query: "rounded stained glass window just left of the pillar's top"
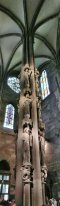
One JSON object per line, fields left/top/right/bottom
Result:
{"left": 7, "top": 77, "right": 20, "bottom": 93}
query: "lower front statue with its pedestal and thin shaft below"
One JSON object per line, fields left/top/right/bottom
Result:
{"left": 22, "top": 114, "right": 32, "bottom": 206}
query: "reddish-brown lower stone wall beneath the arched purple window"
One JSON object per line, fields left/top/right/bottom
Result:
{"left": 0, "top": 131, "right": 16, "bottom": 198}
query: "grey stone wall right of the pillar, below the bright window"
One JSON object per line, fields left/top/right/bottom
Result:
{"left": 42, "top": 65, "right": 60, "bottom": 199}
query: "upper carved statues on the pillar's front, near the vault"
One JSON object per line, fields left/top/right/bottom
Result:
{"left": 19, "top": 64, "right": 32, "bottom": 118}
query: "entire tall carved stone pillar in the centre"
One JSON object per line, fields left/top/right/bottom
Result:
{"left": 16, "top": 35, "right": 44, "bottom": 206}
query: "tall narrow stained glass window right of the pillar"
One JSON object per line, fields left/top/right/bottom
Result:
{"left": 40, "top": 70, "right": 50, "bottom": 99}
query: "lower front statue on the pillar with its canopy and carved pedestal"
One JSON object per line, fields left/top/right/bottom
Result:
{"left": 22, "top": 114, "right": 32, "bottom": 184}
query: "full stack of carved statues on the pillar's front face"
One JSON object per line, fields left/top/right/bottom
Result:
{"left": 19, "top": 64, "right": 33, "bottom": 188}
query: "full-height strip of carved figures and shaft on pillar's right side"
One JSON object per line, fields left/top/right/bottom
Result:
{"left": 35, "top": 66, "right": 47, "bottom": 205}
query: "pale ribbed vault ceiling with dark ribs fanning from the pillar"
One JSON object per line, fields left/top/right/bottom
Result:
{"left": 0, "top": 0, "right": 60, "bottom": 99}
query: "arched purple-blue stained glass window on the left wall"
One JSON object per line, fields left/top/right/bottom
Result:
{"left": 4, "top": 104, "right": 14, "bottom": 129}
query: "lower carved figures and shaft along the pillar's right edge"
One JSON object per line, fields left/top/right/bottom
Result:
{"left": 38, "top": 118, "right": 47, "bottom": 205}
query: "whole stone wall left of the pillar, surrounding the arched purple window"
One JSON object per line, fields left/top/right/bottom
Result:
{"left": 0, "top": 79, "right": 18, "bottom": 197}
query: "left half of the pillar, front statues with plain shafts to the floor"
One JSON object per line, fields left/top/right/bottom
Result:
{"left": 16, "top": 64, "right": 32, "bottom": 206}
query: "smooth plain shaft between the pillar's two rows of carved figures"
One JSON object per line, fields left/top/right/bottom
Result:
{"left": 30, "top": 64, "right": 42, "bottom": 206}
